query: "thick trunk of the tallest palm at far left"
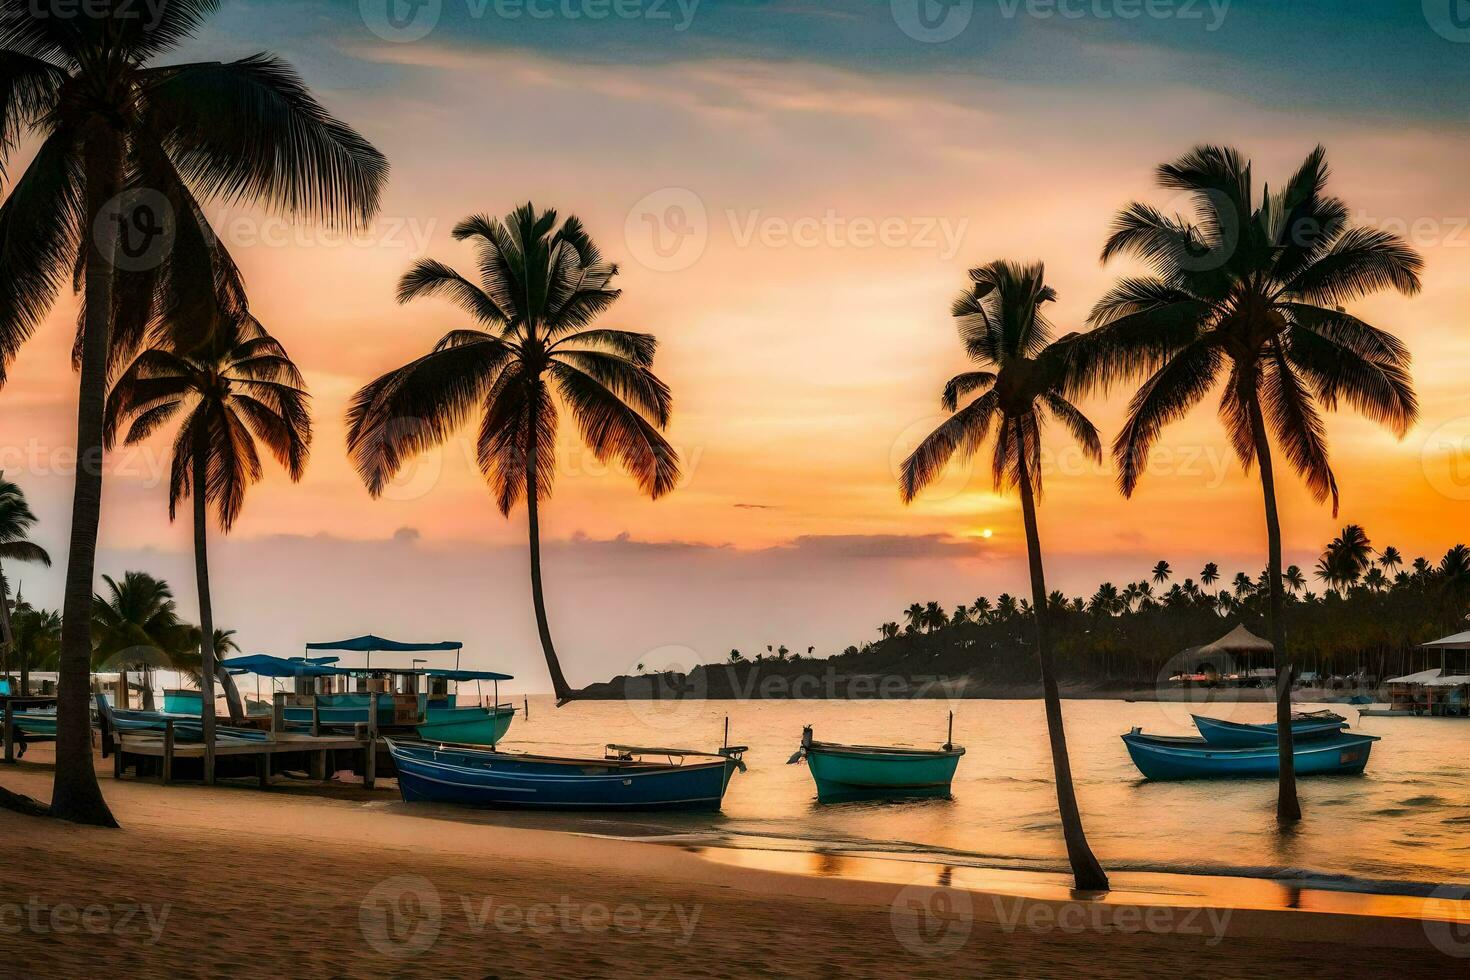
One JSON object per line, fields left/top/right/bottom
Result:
{"left": 51, "top": 123, "right": 122, "bottom": 827}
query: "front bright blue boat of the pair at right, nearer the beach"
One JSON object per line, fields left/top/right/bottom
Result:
{"left": 1123, "top": 729, "right": 1379, "bottom": 780}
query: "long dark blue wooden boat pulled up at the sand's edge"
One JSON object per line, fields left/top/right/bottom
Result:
{"left": 384, "top": 739, "right": 745, "bottom": 810}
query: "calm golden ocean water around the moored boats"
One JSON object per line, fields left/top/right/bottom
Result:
{"left": 473, "top": 698, "right": 1470, "bottom": 890}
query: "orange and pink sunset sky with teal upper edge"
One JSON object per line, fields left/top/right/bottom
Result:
{"left": 0, "top": 0, "right": 1470, "bottom": 691}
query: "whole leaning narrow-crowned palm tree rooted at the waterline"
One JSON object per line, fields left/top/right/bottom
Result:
{"left": 901, "top": 262, "right": 1107, "bottom": 890}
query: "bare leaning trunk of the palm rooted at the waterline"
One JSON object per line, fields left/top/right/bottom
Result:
{"left": 1020, "top": 450, "right": 1108, "bottom": 892}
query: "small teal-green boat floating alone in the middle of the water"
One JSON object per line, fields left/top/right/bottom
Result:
{"left": 786, "top": 716, "right": 964, "bottom": 804}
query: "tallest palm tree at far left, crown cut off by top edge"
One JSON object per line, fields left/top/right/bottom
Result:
{"left": 0, "top": 0, "right": 388, "bottom": 826}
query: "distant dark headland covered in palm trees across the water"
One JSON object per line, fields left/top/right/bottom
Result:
{"left": 842, "top": 525, "right": 1470, "bottom": 686}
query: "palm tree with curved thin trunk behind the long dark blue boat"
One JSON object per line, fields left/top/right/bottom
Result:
{"left": 347, "top": 203, "right": 679, "bottom": 704}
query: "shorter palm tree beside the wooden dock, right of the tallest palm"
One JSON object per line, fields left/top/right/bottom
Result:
{"left": 103, "top": 313, "right": 312, "bottom": 783}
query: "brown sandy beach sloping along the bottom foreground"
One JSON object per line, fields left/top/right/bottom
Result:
{"left": 0, "top": 746, "right": 1467, "bottom": 977}
